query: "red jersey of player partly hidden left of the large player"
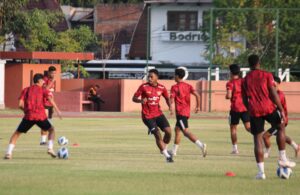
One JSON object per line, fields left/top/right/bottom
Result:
{"left": 226, "top": 78, "right": 247, "bottom": 112}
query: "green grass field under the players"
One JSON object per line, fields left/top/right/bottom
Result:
{"left": 0, "top": 113, "right": 300, "bottom": 195}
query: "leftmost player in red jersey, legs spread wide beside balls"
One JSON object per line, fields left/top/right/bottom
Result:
{"left": 4, "top": 74, "right": 61, "bottom": 159}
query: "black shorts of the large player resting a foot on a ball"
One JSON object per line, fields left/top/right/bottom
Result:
{"left": 250, "top": 110, "right": 281, "bottom": 135}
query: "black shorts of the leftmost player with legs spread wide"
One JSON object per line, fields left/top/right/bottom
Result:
{"left": 17, "top": 118, "right": 52, "bottom": 133}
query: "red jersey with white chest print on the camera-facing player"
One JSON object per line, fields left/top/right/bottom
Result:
{"left": 134, "top": 83, "right": 168, "bottom": 119}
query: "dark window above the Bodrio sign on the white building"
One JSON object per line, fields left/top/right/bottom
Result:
{"left": 168, "top": 11, "right": 198, "bottom": 31}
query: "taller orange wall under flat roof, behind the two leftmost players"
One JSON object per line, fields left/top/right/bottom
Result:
{"left": 5, "top": 63, "right": 61, "bottom": 108}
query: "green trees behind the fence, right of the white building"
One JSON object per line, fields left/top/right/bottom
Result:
{"left": 209, "top": 0, "right": 300, "bottom": 70}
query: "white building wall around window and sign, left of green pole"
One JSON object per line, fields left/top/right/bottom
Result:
{"left": 150, "top": 4, "right": 209, "bottom": 64}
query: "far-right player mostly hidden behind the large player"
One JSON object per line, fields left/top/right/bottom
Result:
{"left": 264, "top": 76, "right": 300, "bottom": 158}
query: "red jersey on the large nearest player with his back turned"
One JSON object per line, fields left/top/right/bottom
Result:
{"left": 243, "top": 70, "right": 276, "bottom": 117}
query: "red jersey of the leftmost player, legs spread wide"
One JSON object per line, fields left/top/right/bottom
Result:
{"left": 19, "top": 85, "right": 49, "bottom": 121}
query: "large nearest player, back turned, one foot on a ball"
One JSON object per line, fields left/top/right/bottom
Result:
{"left": 242, "top": 55, "right": 296, "bottom": 179}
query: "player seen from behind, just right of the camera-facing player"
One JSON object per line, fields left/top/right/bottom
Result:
{"left": 170, "top": 68, "right": 207, "bottom": 157}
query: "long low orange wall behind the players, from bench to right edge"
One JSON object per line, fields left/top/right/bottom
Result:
{"left": 55, "top": 79, "right": 300, "bottom": 113}
